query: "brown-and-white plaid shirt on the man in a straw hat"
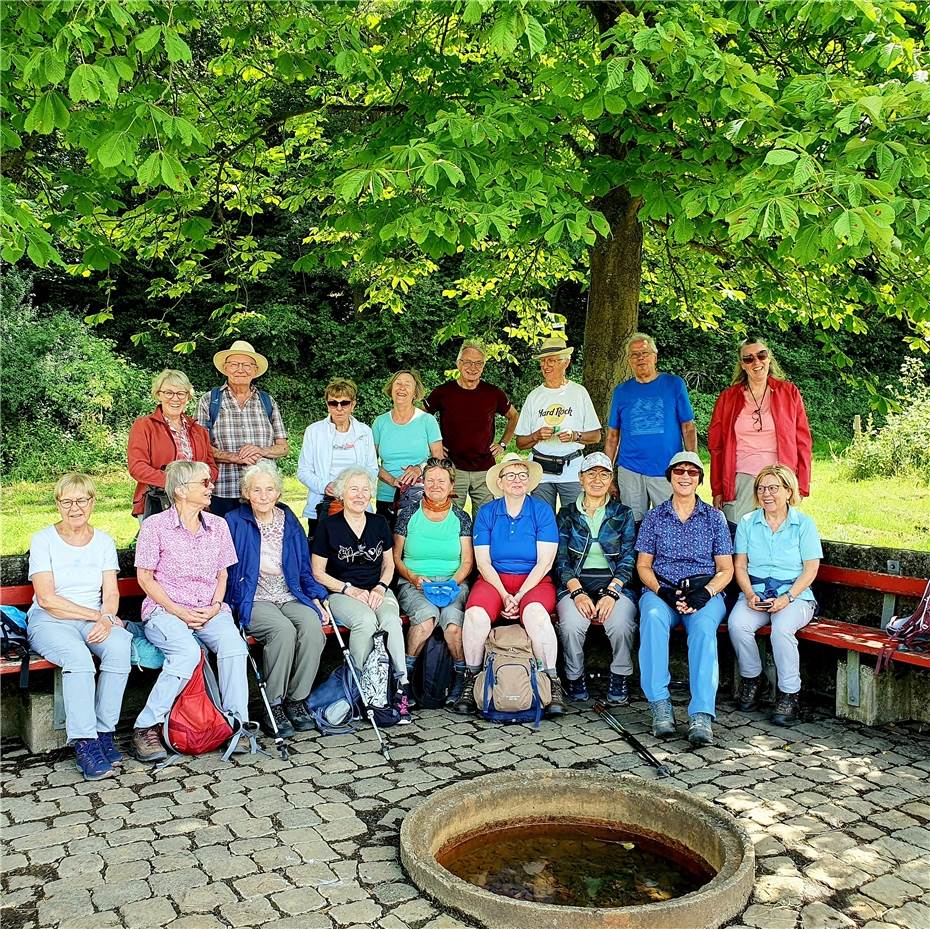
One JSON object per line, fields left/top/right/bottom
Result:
{"left": 197, "top": 384, "right": 287, "bottom": 499}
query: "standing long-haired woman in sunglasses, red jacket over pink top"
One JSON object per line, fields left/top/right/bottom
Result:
{"left": 707, "top": 336, "right": 812, "bottom": 527}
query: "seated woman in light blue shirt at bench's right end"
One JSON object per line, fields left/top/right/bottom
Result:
{"left": 728, "top": 464, "right": 823, "bottom": 726}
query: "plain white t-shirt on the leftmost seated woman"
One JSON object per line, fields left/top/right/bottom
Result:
{"left": 29, "top": 526, "right": 119, "bottom": 610}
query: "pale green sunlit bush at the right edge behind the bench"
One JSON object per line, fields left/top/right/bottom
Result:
{"left": 842, "top": 356, "right": 930, "bottom": 484}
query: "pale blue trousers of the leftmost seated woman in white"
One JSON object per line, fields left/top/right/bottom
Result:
{"left": 29, "top": 606, "right": 132, "bottom": 741}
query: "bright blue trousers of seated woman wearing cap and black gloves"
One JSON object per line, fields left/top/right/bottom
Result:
{"left": 639, "top": 590, "right": 725, "bottom": 716}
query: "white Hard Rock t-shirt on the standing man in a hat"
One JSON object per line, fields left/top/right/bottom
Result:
{"left": 517, "top": 381, "right": 601, "bottom": 484}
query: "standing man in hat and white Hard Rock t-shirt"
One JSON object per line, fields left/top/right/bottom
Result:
{"left": 517, "top": 335, "right": 601, "bottom": 512}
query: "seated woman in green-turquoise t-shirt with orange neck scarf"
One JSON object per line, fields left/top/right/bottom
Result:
{"left": 394, "top": 458, "right": 475, "bottom": 703}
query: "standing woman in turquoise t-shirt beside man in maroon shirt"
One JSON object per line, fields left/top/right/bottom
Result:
{"left": 371, "top": 370, "right": 442, "bottom": 521}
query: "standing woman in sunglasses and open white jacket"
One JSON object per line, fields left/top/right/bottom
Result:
{"left": 297, "top": 377, "right": 378, "bottom": 539}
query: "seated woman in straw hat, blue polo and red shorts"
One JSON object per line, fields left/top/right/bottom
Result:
{"left": 455, "top": 455, "right": 563, "bottom": 716}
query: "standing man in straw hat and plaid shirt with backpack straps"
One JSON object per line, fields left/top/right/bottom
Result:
{"left": 197, "top": 339, "right": 288, "bottom": 516}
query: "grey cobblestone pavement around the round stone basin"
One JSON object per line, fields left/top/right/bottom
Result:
{"left": 2, "top": 703, "right": 930, "bottom": 929}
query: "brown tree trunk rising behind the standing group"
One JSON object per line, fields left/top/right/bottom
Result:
{"left": 583, "top": 180, "right": 643, "bottom": 429}
